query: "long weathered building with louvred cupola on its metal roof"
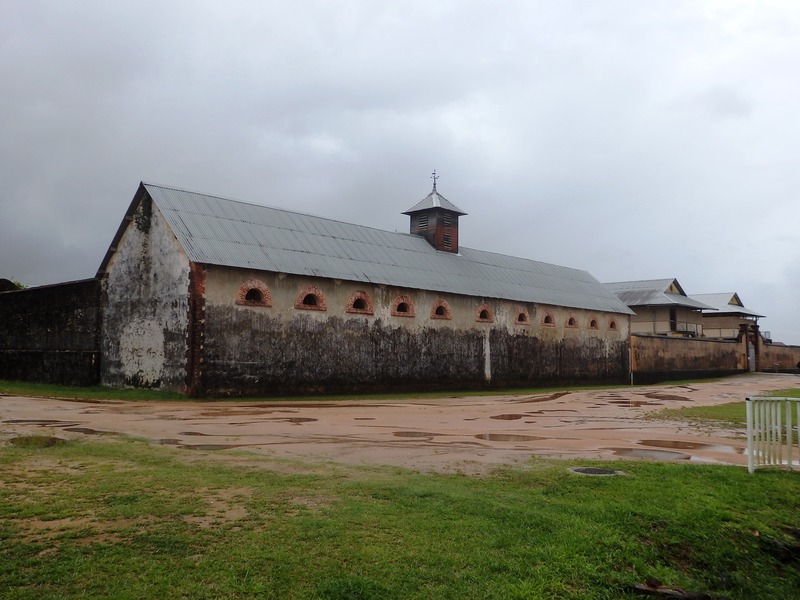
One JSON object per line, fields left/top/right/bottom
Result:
{"left": 98, "top": 178, "right": 632, "bottom": 394}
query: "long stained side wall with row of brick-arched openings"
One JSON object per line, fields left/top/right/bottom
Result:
{"left": 198, "top": 266, "right": 628, "bottom": 394}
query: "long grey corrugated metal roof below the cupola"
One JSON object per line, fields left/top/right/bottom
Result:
{"left": 142, "top": 183, "right": 632, "bottom": 314}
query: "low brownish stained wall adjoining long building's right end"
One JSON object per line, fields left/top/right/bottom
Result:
{"left": 630, "top": 334, "right": 747, "bottom": 383}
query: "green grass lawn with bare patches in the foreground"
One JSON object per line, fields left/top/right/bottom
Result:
{"left": 0, "top": 438, "right": 800, "bottom": 600}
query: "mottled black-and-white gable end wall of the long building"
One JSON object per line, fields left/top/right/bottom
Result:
{"left": 101, "top": 194, "right": 189, "bottom": 391}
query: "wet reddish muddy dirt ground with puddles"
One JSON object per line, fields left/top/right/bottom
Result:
{"left": 0, "top": 374, "right": 800, "bottom": 473}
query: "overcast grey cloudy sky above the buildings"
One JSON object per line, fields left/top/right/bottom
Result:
{"left": 0, "top": 0, "right": 800, "bottom": 344}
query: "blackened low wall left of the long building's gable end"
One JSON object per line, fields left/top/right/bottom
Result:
{"left": 0, "top": 279, "right": 101, "bottom": 385}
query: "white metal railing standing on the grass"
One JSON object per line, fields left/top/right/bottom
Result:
{"left": 747, "top": 397, "right": 800, "bottom": 473}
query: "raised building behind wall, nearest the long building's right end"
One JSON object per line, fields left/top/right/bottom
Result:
{"left": 605, "top": 279, "right": 713, "bottom": 337}
